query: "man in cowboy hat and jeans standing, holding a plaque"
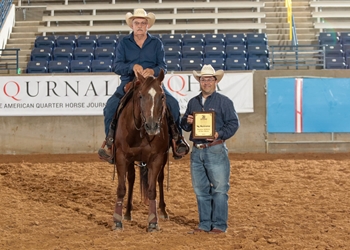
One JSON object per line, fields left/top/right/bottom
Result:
{"left": 181, "top": 65, "right": 239, "bottom": 234}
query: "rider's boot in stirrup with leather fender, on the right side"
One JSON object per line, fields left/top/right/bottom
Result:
{"left": 166, "top": 109, "right": 190, "bottom": 160}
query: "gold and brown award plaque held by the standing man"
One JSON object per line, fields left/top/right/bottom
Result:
{"left": 192, "top": 111, "right": 215, "bottom": 139}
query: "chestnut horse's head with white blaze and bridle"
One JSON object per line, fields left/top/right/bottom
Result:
{"left": 139, "top": 70, "right": 165, "bottom": 135}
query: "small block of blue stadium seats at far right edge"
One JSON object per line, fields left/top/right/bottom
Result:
{"left": 318, "top": 32, "right": 350, "bottom": 69}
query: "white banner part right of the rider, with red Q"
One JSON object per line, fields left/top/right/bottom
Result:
{"left": 164, "top": 72, "right": 254, "bottom": 114}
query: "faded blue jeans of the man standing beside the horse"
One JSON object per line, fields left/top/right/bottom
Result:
{"left": 191, "top": 143, "right": 230, "bottom": 231}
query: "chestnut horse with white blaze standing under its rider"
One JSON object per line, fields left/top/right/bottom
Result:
{"left": 113, "top": 71, "right": 169, "bottom": 232}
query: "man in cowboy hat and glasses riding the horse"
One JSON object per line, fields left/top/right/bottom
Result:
{"left": 98, "top": 9, "right": 189, "bottom": 163}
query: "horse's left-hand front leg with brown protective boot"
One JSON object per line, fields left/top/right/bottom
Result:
{"left": 112, "top": 170, "right": 126, "bottom": 230}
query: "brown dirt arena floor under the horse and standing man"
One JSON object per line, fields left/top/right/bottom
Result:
{"left": 0, "top": 151, "right": 350, "bottom": 250}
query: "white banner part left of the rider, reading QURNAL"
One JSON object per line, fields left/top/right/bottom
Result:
{"left": 0, "top": 75, "right": 119, "bottom": 116}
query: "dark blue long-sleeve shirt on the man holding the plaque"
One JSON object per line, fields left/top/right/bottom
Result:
{"left": 181, "top": 92, "right": 240, "bottom": 143}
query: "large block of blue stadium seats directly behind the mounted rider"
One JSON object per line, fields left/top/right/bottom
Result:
{"left": 27, "top": 33, "right": 269, "bottom": 73}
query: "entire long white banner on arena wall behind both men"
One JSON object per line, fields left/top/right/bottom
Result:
{"left": 0, "top": 73, "right": 254, "bottom": 116}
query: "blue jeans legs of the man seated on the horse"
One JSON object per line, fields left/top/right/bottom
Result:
{"left": 103, "top": 88, "right": 182, "bottom": 137}
